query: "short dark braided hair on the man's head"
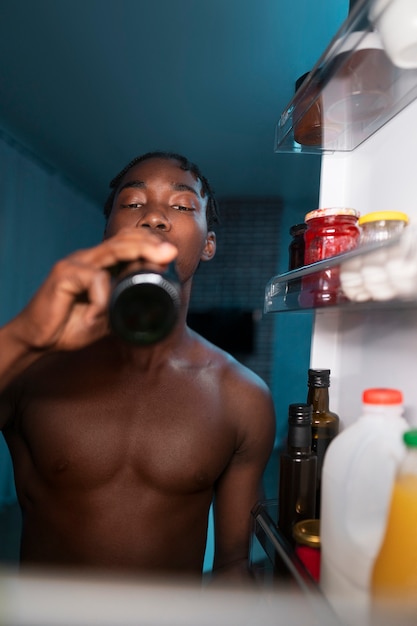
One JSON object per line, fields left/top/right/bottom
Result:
{"left": 104, "top": 152, "right": 219, "bottom": 230}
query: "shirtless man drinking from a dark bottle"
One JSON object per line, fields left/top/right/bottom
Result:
{"left": 0, "top": 153, "right": 275, "bottom": 578}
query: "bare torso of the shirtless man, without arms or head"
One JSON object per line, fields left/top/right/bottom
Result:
{"left": 4, "top": 334, "right": 240, "bottom": 573}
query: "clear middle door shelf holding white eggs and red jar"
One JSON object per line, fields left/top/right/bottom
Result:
{"left": 264, "top": 226, "right": 417, "bottom": 313}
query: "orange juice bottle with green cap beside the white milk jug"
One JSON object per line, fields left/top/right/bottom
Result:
{"left": 372, "top": 430, "right": 417, "bottom": 601}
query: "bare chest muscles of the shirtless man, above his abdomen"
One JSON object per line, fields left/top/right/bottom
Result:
{"left": 13, "top": 366, "right": 235, "bottom": 492}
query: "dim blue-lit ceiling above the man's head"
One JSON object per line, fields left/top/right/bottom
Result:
{"left": 0, "top": 0, "right": 348, "bottom": 210}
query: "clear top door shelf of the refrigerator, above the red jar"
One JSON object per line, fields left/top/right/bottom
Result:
{"left": 275, "top": 0, "right": 417, "bottom": 154}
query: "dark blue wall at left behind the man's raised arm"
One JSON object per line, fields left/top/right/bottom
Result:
{"left": 0, "top": 134, "right": 104, "bottom": 506}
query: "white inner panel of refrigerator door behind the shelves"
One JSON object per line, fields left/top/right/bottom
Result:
{"left": 314, "top": 101, "right": 417, "bottom": 426}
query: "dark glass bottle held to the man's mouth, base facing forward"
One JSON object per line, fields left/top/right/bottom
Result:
{"left": 109, "top": 262, "right": 180, "bottom": 346}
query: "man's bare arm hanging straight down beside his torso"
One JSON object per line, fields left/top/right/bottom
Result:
{"left": 213, "top": 370, "right": 275, "bottom": 582}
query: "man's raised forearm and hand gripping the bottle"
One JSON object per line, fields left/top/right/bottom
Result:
{"left": 0, "top": 229, "right": 176, "bottom": 391}
